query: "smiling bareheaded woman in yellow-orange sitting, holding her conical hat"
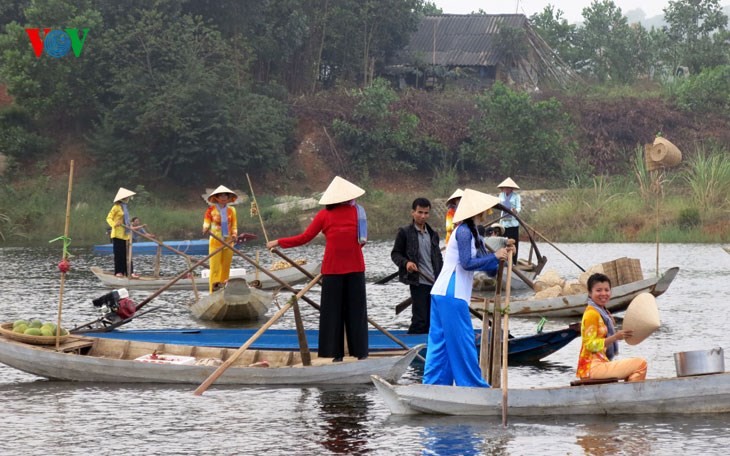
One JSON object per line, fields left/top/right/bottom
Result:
{"left": 577, "top": 273, "right": 647, "bottom": 382}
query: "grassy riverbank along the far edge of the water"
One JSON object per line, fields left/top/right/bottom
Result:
{"left": 0, "top": 167, "right": 730, "bottom": 247}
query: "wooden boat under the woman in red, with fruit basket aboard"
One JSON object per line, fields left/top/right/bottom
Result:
{"left": 0, "top": 335, "right": 420, "bottom": 385}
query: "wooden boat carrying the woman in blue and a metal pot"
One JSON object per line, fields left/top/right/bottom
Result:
{"left": 373, "top": 372, "right": 730, "bottom": 416}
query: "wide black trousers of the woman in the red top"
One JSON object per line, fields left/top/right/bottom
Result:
{"left": 319, "top": 272, "right": 368, "bottom": 358}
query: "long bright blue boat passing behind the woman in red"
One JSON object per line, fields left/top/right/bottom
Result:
{"left": 86, "top": 324, "right": 580, "bottom": 364}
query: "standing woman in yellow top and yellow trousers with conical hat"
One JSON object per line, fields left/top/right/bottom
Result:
{"left": 203, "top": 185, "right": 238, "bottom": 293}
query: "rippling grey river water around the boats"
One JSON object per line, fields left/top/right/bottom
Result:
{"left": 0, "top": 242, "right": 730, "bottom": 455}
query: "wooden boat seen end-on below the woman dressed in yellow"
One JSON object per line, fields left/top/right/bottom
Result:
{"left": 190, "top": 279, "right": 274, "bottom": 321}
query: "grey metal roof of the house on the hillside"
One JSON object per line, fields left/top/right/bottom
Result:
{"left": 405, "top": 14, "right": 527, "bottom": 66}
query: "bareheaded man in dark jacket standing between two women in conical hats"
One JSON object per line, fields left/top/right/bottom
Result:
{"left": 390, "top": 198, "right": 443, "bottom": 334}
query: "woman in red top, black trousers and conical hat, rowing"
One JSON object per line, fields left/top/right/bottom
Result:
{"left": 266, "top": 176, "right": 368, "bottom": 362}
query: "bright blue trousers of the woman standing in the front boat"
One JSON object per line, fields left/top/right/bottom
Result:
{"left": 423, "top": 274, "right": 489, "bottom": 388}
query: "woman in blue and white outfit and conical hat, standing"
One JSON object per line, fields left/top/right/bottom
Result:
{"left": 423, "top": 189, "right": 514, "bottom": 388}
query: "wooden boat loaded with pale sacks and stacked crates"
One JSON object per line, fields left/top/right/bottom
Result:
{"left": 471, "top": 267, "right": 679, "bottom": 318}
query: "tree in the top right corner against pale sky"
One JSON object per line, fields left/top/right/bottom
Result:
{"left": 664, "top": 0, "right": 730, "bottom": 74}
